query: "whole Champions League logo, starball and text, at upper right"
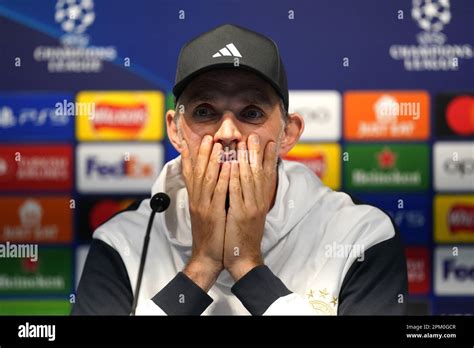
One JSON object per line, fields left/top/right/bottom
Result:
{"left": 389, "top": 0, "right": 473, "bottom": 71}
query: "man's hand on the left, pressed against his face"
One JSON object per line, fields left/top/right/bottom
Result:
{"left": 181, "top": 135, "right": 230, "bottom": 291}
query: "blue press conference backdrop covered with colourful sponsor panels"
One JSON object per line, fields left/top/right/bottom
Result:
{"left": 0, "top": 0, "right": 474, "bottom": 315}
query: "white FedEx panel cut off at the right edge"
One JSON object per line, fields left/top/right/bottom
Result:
{"left": 435, "top": 246, "right": 474, "bottom": 296}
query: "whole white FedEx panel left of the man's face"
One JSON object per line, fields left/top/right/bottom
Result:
{"left": 76, "top": 143, "right": 164, "bottom": 193}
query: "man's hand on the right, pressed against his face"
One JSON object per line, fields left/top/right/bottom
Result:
{"left": 224, "top": 134, "right": 277, "bottom": 281}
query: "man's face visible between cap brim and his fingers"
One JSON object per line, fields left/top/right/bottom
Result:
{"left": 174, "top": 69, "right": 284, "bottom": 166}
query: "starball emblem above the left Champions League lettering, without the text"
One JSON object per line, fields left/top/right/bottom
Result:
{"left": 54, "top": 0, "right": 95, "bottom": 46}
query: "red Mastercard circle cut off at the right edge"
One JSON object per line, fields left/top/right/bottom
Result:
{"left": 446, "top": 96, "right": 474, "bottom": 135}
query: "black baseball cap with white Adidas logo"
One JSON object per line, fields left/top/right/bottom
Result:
{"left": 173, "top": 24, "right": 288, "bottom": 110}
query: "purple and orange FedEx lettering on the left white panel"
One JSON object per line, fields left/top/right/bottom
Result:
{"left": 86, "top": 156, "right": 153, "bottom": 178}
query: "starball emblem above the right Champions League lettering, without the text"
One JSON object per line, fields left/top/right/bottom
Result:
{"left": 411, "top": 0, "right": 451, "bottom": 45}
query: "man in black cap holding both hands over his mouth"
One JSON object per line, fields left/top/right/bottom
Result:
{"left": 73, "top": 25, "right": 407, "bottom": 315}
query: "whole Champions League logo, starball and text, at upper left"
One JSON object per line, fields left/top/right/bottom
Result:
{"left": 33, "top": 0, "right": 117, "bottom": 73}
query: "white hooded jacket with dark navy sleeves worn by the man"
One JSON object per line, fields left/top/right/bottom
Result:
{"left": 73, "top": 157, "right": 407, "bottom": 315}
